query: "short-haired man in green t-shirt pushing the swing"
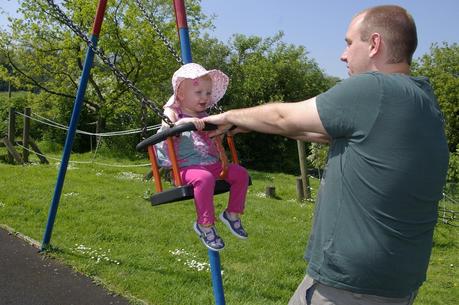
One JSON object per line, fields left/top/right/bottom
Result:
{"left": 205, "top": 6, "right": 448, "bottom": 305}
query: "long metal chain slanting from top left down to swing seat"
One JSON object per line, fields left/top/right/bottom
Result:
{"left": 46, "top": 0, "right": 174, "bottom": 127}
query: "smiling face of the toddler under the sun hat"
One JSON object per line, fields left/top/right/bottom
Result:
{"left": 177, "top": 76, "right": 212, "bottom": 116}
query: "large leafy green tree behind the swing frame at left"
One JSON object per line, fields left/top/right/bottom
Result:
{"left": 0, "top": 0, "right": 210, "bottom": 150}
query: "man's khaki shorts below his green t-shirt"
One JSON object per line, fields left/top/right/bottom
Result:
{"left": 288, "top": 275, "right": 417, "bottom": 305}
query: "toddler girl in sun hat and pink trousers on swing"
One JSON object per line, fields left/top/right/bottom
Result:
{"left": 157, "top": 63, "right": 249, "bottom": 251}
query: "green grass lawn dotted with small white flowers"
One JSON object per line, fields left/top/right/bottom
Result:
{"left": 0, "top": 149, "right": 459, "bottom": 305}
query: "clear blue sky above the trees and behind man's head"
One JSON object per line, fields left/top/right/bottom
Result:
{"left": 0, "top": 0, "right": 459, "bottom": 78}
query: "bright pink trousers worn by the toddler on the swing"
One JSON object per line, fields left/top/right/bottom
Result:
{"left": 180, "top": 163, "right": 249, "bottom": 224}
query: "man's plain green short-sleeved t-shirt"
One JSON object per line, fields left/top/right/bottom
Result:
{"left": 305, "top": 72, "right": 448, "bottom": 297}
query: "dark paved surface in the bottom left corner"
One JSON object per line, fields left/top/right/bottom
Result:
{"left": 0, "top": 227, "right": 133, "bottom": 305}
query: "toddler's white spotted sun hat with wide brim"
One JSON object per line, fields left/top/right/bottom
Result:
{"left": 164, "top": 63, "right": 229, "bottom": 107}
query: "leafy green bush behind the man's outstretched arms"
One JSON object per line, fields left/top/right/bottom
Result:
{"left": 205, "top": 32, "right": 330, "bottom": 173}
